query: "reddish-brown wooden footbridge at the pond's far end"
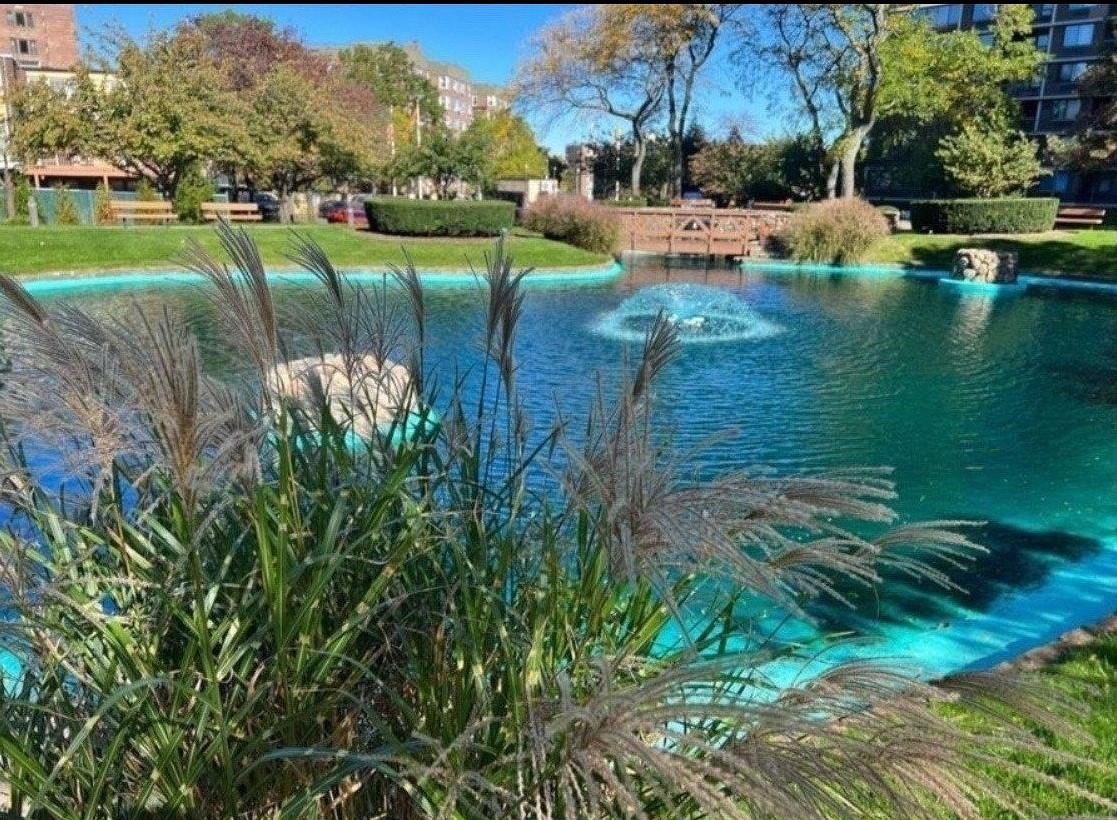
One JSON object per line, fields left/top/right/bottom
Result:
{"left": 617, "top": 208, "right": 791, "bottom": 256}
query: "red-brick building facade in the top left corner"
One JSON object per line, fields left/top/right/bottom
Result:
{"left": 0, "top": 3, "right": 78, "bottom": 69}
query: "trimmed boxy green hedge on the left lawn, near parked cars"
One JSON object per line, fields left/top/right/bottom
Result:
{"left": 364, "top": 197, "right": 516, "bottom": 237}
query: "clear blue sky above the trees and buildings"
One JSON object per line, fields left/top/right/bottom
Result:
{"left": 77, "top": 3, "right": 782, "bottom": 151}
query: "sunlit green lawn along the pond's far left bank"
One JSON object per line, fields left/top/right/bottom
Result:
{"left": 0, "top": 225, "right": 609, "bottom": 276}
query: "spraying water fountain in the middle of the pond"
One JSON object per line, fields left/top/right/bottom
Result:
{"left": 593, "top": 283, "right": 783, "bottom": 344}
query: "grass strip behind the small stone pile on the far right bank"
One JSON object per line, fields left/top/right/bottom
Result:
{"left": 866, "top": 229, "right": 1117, "bottom": 279}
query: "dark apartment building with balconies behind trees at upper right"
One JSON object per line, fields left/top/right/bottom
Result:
{"left": 915, "top": 3, "right": 1117, "bottom": 203}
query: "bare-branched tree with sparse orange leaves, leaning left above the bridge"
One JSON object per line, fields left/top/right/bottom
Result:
{"left": 513, "top": 6, "right": 667, "bottom": 194}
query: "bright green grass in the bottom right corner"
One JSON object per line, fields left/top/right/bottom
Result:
{"left": 957, "top": 635, "right": 1117, "bottom": 819}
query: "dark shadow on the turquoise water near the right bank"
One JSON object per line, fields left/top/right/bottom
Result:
{"left": 811, "top": 522, "right": 1104, "bottom": 631}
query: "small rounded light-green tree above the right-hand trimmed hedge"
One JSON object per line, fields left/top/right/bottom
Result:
{"left": 936, "top": 117, "right": 1048, "bottom": 198}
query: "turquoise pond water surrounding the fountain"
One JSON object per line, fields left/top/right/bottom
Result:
{"left": 4, "top": 258, "right": 1117, "bottom": 675}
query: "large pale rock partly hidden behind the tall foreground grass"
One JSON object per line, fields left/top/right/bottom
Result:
{"left": 266, "top": 353, "right": 412, "bottom": 438}
